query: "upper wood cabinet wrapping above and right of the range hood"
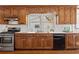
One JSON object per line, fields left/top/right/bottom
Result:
{"left": 4, "top": 7, "right": 26, "bottom": 24}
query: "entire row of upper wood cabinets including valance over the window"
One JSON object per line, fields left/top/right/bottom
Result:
{"left": 0, "top": 6, "right": 76, "bottom": 24}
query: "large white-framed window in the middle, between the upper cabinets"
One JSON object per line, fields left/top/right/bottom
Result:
{"left": 28, "top": 13, "right": 56, "bottom": 32}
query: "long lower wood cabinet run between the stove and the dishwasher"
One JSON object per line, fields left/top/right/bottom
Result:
{"left": 15, "top": 34, "right": 53, "bottom": 49}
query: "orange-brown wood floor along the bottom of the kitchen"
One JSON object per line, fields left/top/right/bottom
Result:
{"left": 0, "top": 50, "right": 79, "bottom": 54}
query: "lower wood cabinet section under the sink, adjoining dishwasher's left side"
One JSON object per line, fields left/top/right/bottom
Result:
{"left": 33, "top": 34, "right": 53, "bottom": 49}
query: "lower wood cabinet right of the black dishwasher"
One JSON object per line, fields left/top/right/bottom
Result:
{"left": 66, "top": 33, "right": 79, "bottom": 49}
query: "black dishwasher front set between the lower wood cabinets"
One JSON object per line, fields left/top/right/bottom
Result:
{"left": 53, "top": 33, "right": 65, "bottom": 50}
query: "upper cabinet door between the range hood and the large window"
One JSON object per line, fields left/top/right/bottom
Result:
{"left": 18, "top": 8, "right": 26, "bottom": 24}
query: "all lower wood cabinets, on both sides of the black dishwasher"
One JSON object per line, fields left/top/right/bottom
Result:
{"left": 15, "top": 33, "right": 79, "bottom": 49}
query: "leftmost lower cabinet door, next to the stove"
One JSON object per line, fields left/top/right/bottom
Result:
{"left": 15, "top": 37, "right": 25, "bottom": 49}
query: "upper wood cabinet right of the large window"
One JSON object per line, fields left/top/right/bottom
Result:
{"left": 58, "top": 6, "right": 76, "bottom": 24}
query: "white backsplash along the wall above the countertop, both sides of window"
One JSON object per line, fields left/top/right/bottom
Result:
{"left": 0, "top": 24, "right": 76, "bottom": 32}
